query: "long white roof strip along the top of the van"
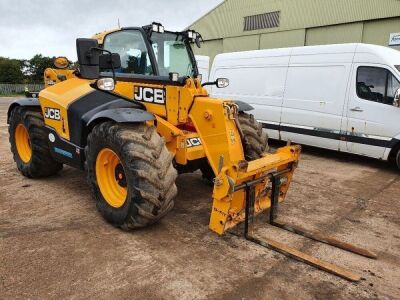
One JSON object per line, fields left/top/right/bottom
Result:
{"left": 215, "top": 43, "right": 400, "bottom": 65}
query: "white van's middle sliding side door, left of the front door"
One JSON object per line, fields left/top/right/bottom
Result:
{"left": 280, "top": 63, "right": 351, "bottom": 150}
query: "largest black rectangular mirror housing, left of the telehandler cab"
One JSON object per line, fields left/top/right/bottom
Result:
{"left": 76, "top": 38, "right": 100, "bottom": 79}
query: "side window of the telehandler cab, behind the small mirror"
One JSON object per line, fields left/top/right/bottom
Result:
{"left": 101, "top": 30, "right": 153, "bottom": 75}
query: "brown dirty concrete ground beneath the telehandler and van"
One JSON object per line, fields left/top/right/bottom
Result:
{"left": 0, "top": 98, "right": 400, "bottom": 299}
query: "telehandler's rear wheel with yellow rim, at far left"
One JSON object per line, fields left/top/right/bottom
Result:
{"left": 8, "top": 106, "right": 63, "bottom": 178}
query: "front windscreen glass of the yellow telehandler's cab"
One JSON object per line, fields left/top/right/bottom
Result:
{"left": 151, "top": 32, "right": 194, "bottom": 77}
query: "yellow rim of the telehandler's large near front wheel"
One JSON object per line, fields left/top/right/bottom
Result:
{"left": 96, "top": 148, "right": 128, "bottom": 208}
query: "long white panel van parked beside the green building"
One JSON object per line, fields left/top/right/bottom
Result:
{"left": 209, "top": 44, "right": 400, "bottom": 167}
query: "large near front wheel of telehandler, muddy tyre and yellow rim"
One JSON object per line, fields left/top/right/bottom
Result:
{"left": 85, "top": 122, "right": 177, "bottom": 230}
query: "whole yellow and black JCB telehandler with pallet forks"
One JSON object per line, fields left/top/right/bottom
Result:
{"left": 8, "top": 23, "right": 374, "bottom": 280}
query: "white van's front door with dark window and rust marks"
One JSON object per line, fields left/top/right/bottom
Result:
{"left": 346, "top": 64, "right": 400, "bottom": 158}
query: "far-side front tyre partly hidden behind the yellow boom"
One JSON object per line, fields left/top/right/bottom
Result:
{"left": 200, "top": 112, "right": 269, "bottom": 182}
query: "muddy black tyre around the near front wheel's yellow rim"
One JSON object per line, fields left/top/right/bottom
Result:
{"left": 85, "top": 122, "right": 177, "bottom": 230}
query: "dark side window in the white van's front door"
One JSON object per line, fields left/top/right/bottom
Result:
{"left": 357, "top": 67, "right": 400, "bottom": 105}
